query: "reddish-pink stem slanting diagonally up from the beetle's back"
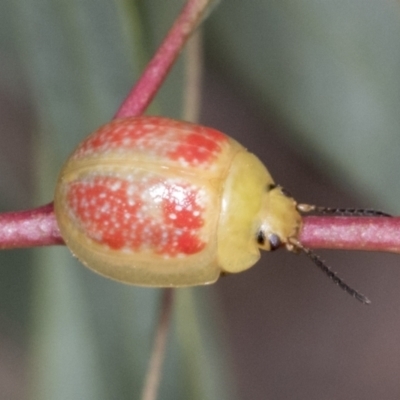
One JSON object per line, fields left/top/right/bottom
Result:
{"left": 114, "top": 0, "right": 210, "bottom": 118}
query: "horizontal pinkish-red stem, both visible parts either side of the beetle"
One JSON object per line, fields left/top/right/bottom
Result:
{"left": 0, "top": 203, "right": 400, "bottom": 253}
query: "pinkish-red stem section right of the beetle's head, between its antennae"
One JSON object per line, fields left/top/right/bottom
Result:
{"left": 299, "top": 216, "right": 400, "bottom": 253}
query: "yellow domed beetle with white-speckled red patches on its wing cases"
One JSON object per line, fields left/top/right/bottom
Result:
{"left": 54, "top": 116, "right": 384, "bottom": 302}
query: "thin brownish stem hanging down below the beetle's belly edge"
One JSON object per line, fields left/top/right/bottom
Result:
{"left": 141, "top": 289, "right": 174, "bottom": 400}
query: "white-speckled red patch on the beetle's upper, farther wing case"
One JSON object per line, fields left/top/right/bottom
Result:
{"left": 74, "top": 117, "right": 228, "bottom": 166}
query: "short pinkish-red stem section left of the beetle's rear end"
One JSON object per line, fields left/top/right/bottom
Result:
{"left": 0, "top": 203, "right": 64, "bottom": 249}
